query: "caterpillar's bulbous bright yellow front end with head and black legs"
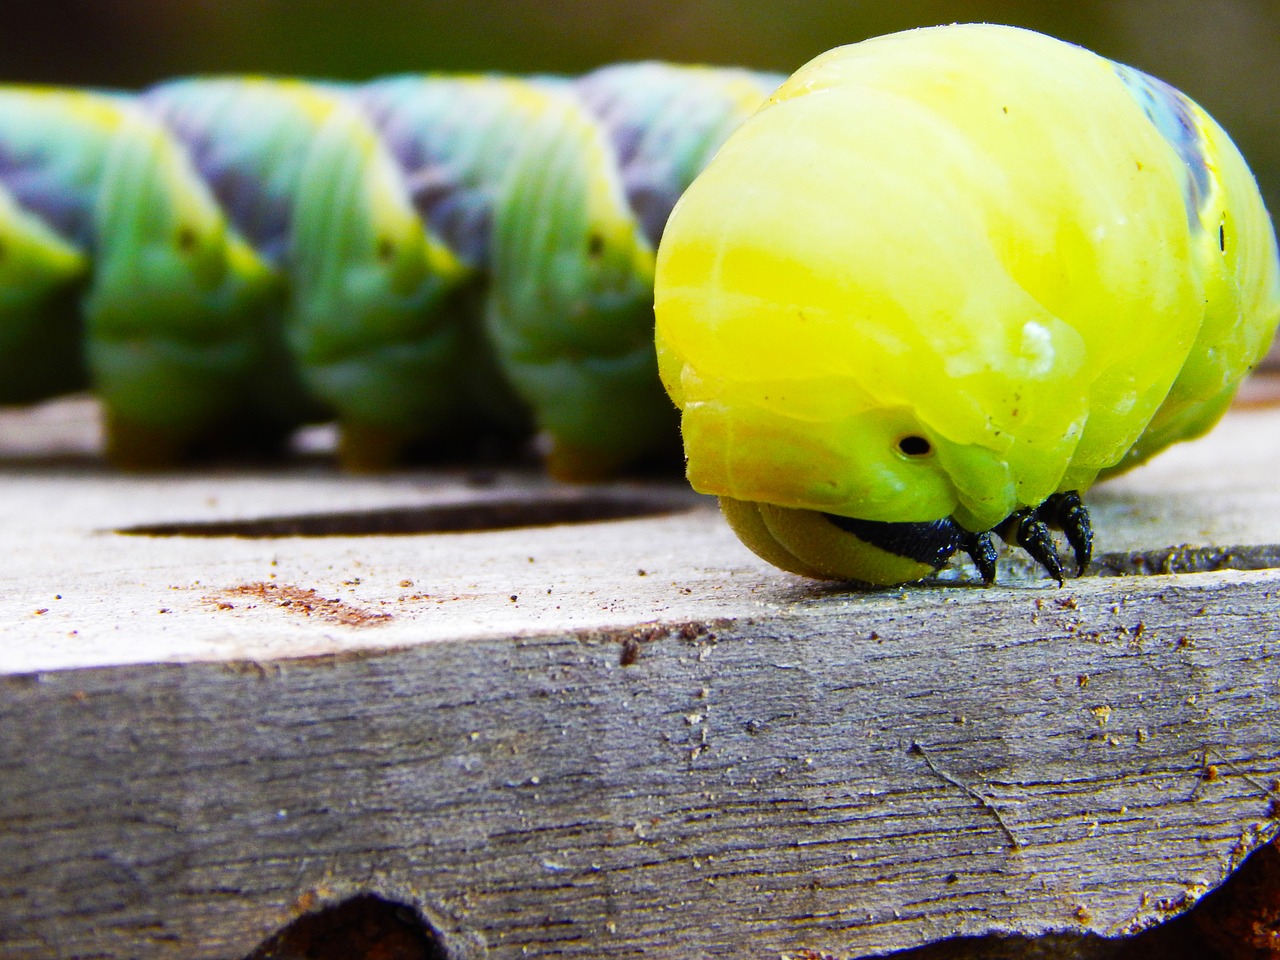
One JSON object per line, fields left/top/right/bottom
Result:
{"left": 655, "top": 24, "right": 1280, "bottom": 584}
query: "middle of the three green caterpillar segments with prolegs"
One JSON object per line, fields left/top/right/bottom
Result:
{"left": 146, "top": 79, "right": 466, "bottom": 468}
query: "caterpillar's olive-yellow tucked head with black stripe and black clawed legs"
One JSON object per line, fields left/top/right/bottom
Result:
{"left": 719, "top": 490, "right": 1093, "bottom": 586}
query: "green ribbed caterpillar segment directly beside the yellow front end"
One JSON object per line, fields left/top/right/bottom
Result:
{"left": 485, "top": 82, "right": 660, "bottom": 479}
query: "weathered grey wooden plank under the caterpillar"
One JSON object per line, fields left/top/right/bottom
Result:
{"left": 0, "top": 394, "right": 1280, "bottom": 960}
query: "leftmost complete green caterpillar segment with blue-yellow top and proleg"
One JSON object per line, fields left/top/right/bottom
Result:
{"left": 0, "top": 90, "right": 284, "bottom": 466}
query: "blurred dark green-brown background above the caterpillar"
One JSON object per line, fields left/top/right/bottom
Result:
{"left": 0, "top": 0, "right": 1280, "bottom": 210}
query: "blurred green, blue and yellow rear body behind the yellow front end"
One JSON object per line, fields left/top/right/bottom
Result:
{"left": 0, "top": 63, "right": 783, "bottom": 480}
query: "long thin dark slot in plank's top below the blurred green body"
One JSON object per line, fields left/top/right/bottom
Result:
{"left": 115, "top": 490, "right": 696, "bottom": 539}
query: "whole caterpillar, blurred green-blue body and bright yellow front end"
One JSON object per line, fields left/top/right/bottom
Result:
{"left": 0, "top": 24, "right": 1280, "bottom": 584}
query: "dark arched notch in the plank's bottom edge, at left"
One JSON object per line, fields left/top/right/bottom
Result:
{"left": 244, "top": 893, "right": 449, "bottom": 960}
